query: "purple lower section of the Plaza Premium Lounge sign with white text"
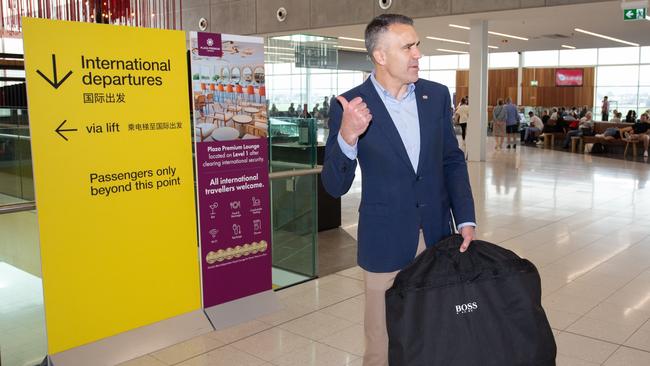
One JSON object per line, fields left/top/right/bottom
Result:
{"left": 196, "top": 139, "right": 272, "bottom": 308}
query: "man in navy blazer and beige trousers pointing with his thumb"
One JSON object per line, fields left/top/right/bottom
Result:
{"left": 322, "top": 14, "right": 476, "bottom": 366}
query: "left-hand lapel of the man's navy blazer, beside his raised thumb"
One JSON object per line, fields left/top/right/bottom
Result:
{"left": 360, "top": 77, "right": 415, "bottom": 174}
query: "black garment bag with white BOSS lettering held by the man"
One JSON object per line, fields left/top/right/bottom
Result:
{"left": 386, "top": 235, "right": 557, "bottom": 366}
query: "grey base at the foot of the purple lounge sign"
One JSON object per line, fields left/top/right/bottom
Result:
{"left": 205, "top": 290, "right": 282, "bottom": 330}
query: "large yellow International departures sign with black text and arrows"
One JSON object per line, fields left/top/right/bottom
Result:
{"left": 23, "top": 18, "right": 201, "bottom": 354}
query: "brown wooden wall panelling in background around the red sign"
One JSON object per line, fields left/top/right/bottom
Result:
{"left": 456, "top": 67, "right": 596, "bottom": 108}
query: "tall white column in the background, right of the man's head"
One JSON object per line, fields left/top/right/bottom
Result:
{"left": 466, "top": 20, "right": 488, "bottom": 161}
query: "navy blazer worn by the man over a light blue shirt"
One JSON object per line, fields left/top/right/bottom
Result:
{"left": 321, "top": 78, "right": 475, "bottom": 272}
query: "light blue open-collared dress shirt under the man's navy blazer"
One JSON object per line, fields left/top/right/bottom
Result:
{"left": 337, "top": 72, "right": 476, "bottom": 230}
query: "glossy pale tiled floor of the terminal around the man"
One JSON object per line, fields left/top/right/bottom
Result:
{"left": 116, "top": 139, "right": 650, "bottom": 366}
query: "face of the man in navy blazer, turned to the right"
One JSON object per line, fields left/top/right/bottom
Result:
{"left": 375, "top": 24, "right": 422, "bottom": 84}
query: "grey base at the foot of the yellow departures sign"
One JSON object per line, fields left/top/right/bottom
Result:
{"left": 49, "top": 310, "right": 213, "bottom": 366}
